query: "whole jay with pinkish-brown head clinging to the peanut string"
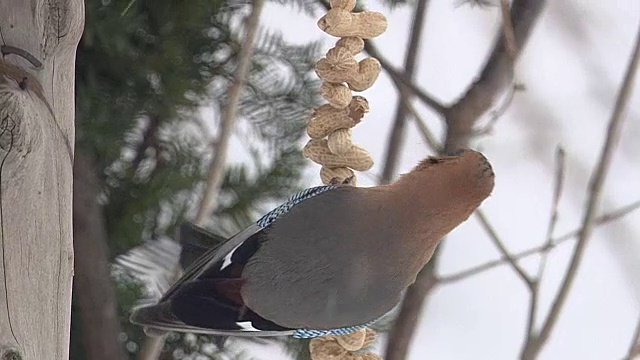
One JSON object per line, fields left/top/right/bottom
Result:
{"left": 131, "top": 150, "right": 494, "bottom": 338}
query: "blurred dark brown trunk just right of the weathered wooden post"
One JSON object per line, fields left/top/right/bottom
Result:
{"left": 73, "top": 152, "right": 127, "bottom": 360}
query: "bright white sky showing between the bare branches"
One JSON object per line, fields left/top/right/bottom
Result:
{"left": 232, "top": 0, "right": 640, "bottom": 360}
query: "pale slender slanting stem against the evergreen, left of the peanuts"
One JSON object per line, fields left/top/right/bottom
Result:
{"left": 138, "top": 0, "right": 264, "bottom": 360}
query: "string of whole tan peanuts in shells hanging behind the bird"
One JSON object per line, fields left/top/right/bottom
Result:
{"left": 303, "top": 0, "right": 387, "bottom": 360}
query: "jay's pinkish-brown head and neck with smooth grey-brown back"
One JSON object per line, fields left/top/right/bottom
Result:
{"left": 242, "top": 151, "right": 494, "bottom": 329}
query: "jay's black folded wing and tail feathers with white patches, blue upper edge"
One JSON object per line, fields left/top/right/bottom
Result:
{"left": 131, "top": 185, "right": 336, "bottom": 336}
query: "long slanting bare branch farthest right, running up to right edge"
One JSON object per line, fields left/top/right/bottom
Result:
{"left": 522, "top": 20, "right": 640, "bottom": 360}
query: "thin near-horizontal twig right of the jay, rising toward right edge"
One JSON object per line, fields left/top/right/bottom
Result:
{"left": 438, "top": 200, "right": 640, "bottom": 284}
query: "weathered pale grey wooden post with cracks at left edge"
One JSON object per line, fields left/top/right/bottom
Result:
{"left": 0, "top": 0, "right": 84, "bottom": 360}
